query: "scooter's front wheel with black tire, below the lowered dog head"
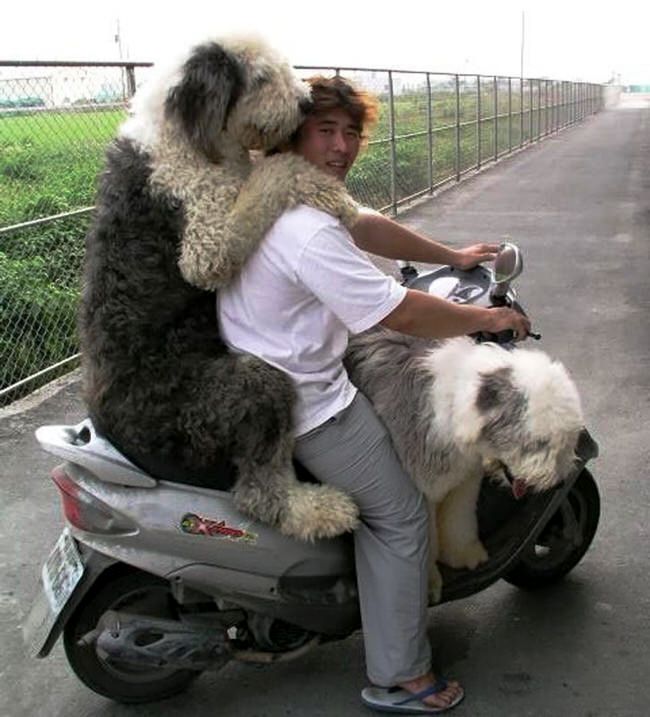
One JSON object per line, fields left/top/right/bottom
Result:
{"left": 504, "top": 470, "right": 600, "bottom": 590}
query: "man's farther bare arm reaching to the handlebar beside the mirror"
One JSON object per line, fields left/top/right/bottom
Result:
{"left": 351, "top": 214, "right": 498, "bottom": 269}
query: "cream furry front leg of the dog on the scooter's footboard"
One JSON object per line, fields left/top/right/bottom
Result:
{"left": 437, "top": 472, "right": 488, "bottom": 570}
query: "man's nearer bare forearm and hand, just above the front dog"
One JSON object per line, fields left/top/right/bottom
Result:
{"left": 379, "top": 289, "right": 530, "bottom": 340}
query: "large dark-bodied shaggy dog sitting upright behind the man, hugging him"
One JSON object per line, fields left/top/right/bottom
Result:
{"left": 80, "top": 33, "right": 357, "bottom": 539}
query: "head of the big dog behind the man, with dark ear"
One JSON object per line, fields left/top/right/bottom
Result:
{"left": 165, "top": 40, "right": 309, "bottom": 160}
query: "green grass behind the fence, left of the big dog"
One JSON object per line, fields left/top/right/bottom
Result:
{"left": 0, "top": 110, "right": 125, "bottom": 389}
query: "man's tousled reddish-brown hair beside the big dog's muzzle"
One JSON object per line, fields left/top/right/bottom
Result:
{"left": 305, "top": 75, "right": 378, "bottom": 133}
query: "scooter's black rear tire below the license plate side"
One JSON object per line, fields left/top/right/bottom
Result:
{"left": 63, "top": 569, "right": 201, "bottom": 704}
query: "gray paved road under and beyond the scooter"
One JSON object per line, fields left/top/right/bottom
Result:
{"left": 0, "top": 104, "right": 650, "bottom": 717}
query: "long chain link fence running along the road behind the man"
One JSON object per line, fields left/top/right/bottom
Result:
{"left": 0, "top": 62, "right": 603, "bottom": 405}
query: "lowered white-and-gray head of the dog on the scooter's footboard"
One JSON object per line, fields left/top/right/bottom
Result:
{"left": 475, "top": 350, "right": 584, "bottom": 497}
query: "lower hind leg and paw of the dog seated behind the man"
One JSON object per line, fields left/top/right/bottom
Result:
{"left": 234, "top": 440, "right": 359, "bottom": 540}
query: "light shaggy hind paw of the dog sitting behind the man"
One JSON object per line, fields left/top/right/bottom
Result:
{"left": 279, "top": 484, "right": 359, "bottom": 540}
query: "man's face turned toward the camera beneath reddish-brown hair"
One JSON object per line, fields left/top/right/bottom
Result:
{"left": 294, "top": 109, "right": 361, "bottom": 180}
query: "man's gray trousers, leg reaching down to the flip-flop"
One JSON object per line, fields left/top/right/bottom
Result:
{"left": 295, "top": 392, "right": 431, "bottom": 687}
